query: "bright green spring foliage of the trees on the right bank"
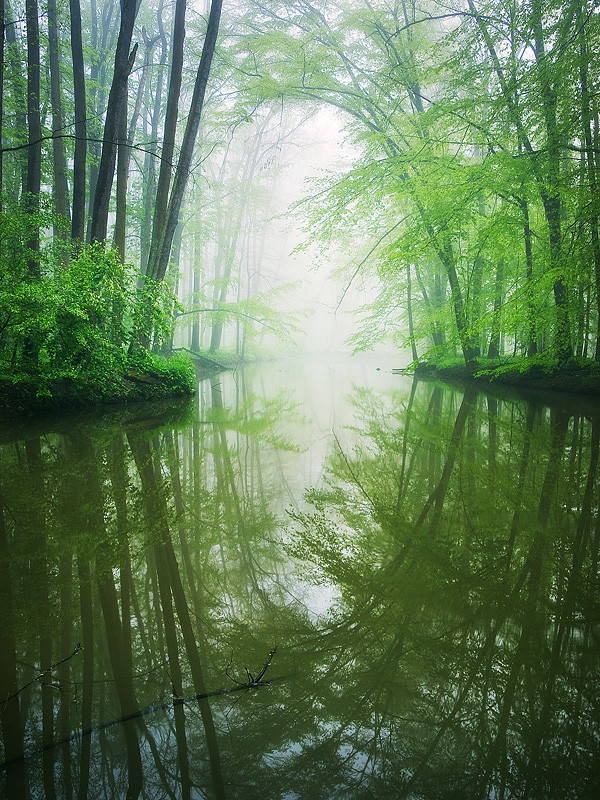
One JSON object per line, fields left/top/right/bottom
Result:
{"left": 237, "top": 0, "right": 600, "bottom": 362}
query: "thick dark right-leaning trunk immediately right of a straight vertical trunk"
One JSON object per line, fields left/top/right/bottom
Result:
{"left": 91, "top": 0, "right": 137, "bottom": 242}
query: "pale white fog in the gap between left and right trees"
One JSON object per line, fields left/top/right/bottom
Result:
{"left": 175, "top": 108, "right": 410, "bottom": 363}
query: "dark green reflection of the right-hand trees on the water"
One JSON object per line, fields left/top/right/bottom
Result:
{"left": 284, "top": 382, "right": 598, "bottom": 798}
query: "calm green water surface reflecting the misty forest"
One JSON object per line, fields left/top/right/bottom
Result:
{"left": 0, "top": 360, "right": 600, "bottom": 800}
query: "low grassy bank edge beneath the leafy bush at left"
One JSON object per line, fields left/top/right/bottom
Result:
{"left": 0, "top": 356, "right": 214, "bottom": 419}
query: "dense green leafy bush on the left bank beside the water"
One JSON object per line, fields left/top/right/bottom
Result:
{"left": 0, "top": 204, "right": 195, "bottom": 410}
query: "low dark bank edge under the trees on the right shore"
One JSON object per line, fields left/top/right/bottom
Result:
{"left": 414, "top": 359, "right": 600, "bottom": 397}
